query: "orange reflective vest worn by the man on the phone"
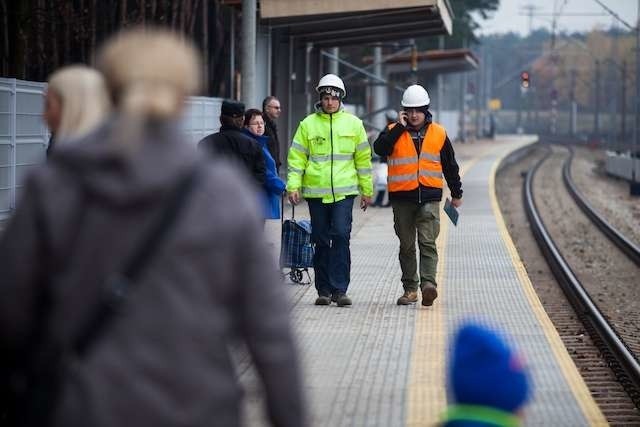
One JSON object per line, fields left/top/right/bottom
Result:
{"left": 387, "top": 123, "right": 447, "bottom": 191}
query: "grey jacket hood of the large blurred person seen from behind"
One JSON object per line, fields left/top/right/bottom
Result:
{"left": 49, "top": 116, "right": 197, "bottom": 206}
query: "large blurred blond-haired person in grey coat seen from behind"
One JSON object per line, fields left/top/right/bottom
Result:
{"left": 0, "top": 29, "right": 305, "bottom": 427}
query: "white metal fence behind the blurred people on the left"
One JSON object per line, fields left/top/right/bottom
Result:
{"left": 0, "top": 78, "right": 222, "bottom": 221}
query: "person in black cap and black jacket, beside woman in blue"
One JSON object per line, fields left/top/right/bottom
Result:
{"left": 198, "top": 99, "right": 266, "bottom": 189}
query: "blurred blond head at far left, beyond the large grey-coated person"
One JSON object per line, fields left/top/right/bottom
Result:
{"left": 44, "top": 65, "right": 111, "bottom": 155}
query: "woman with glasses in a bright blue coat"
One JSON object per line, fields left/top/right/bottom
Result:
{"left": 244, "top": 109, "right": 286, "bottom": 219}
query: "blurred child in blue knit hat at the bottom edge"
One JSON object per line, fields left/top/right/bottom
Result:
{"left": 442, "top": 322, "right": 531, "bottom": 427}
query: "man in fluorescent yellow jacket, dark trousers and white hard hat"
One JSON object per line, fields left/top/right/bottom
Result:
{"left": 287, "top": 74, "right": 373, "bottom": 307}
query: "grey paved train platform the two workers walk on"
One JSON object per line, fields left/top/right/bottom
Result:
{"left": 240, "top": 136, "right": 607, "bottom": 427}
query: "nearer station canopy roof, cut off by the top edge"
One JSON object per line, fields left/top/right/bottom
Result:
{"left": 260, "top": 0, "right": 452, "bottom": 47}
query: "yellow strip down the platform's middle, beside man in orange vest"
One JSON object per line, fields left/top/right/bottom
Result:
{"left": 406, "top": 158, "right": 480, "bottom": 427}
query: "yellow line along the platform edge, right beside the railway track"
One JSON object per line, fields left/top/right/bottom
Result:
{"left": 489, "top": 146, "right": 608, "bottom": 426}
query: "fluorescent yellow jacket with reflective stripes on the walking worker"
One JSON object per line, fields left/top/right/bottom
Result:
{"left": 287, "top": 110, "right": 373, "bottom": 203}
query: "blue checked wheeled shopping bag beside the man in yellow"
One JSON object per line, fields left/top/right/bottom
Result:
{"left": 280, "top": 199, "right": 314, "bottom": 285}
